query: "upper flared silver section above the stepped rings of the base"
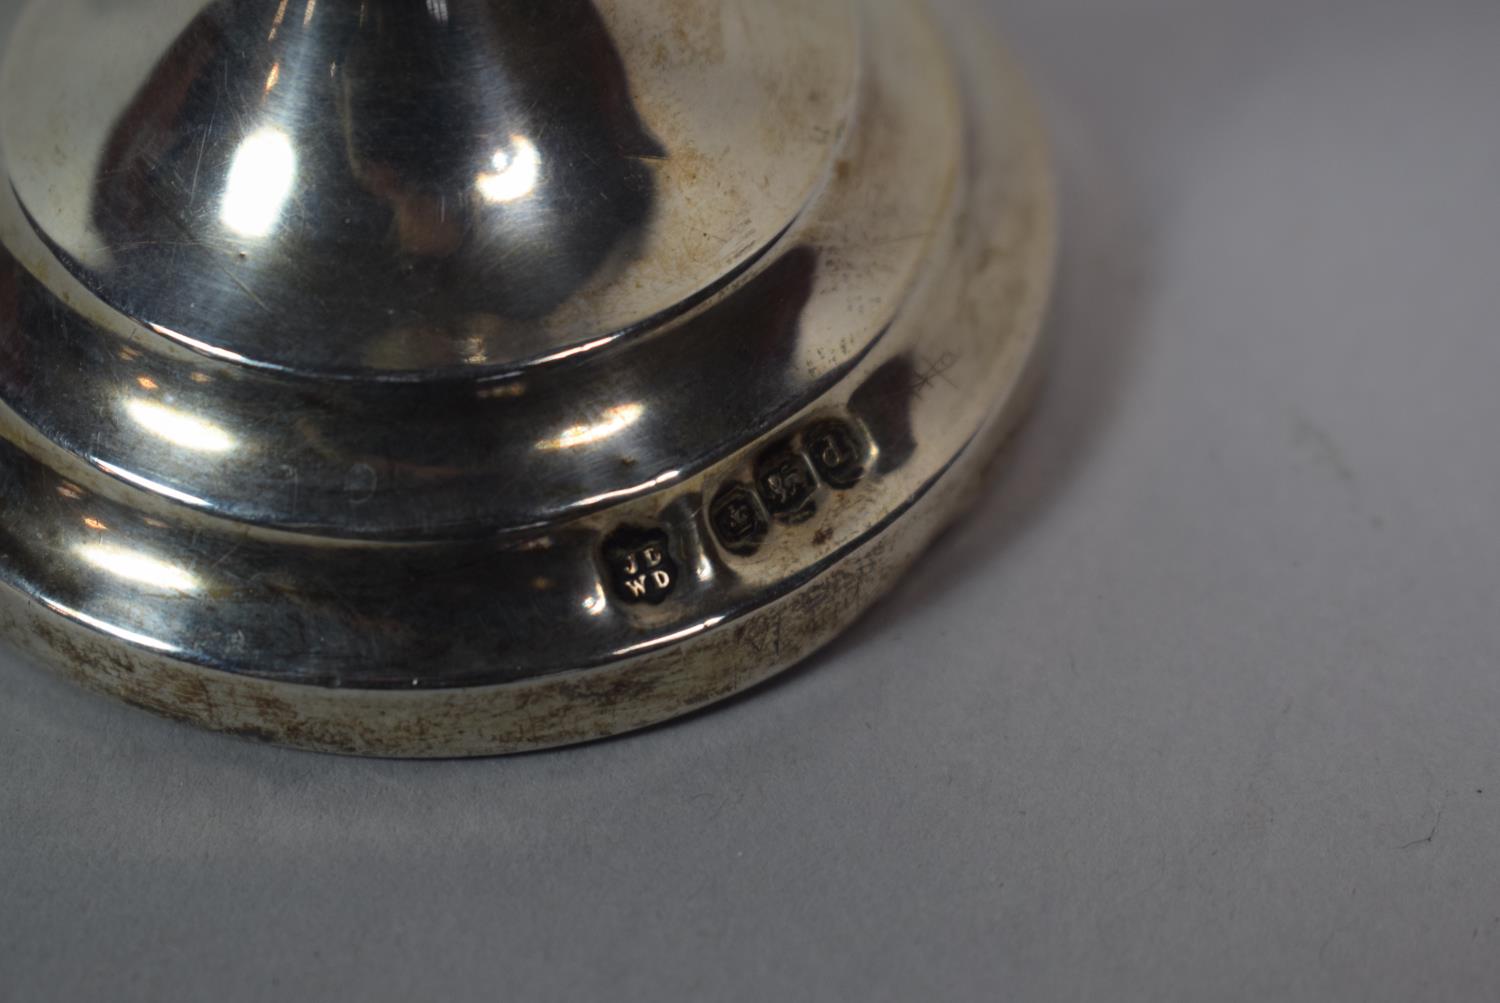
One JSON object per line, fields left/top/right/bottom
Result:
{"left": 0, "top": 0, "right": 858, "bottom": 371}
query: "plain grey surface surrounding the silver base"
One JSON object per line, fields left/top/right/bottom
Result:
{"left": 0, "top": 0, "right": 1500, "bottom": 1000}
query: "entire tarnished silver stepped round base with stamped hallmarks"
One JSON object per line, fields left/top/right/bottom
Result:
{"left": 0, "top": 0, "right": 1055, "bottom": 756}
